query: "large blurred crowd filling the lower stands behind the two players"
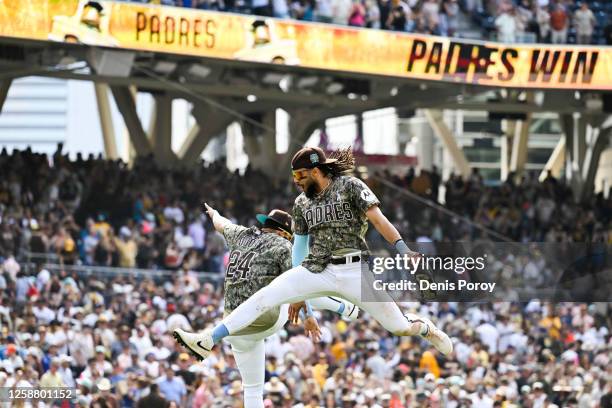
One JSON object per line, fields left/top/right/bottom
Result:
{"left": 0, "top": 150, "right": 612, "bottom": 408}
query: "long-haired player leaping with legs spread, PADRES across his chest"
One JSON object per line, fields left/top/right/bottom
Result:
{"left": 177, "top": 147, "right": 453, "bottom": 364}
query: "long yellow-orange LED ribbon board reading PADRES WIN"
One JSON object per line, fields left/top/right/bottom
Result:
{"left": 0, "top": 0, "right": 612, "bottom": 90}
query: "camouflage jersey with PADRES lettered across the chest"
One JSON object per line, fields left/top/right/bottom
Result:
{"left": 293, "top": 176, "right": 380, "bottom": 273}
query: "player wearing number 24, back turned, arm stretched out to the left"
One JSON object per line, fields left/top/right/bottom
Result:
{"left": 175, "top": 204, "right": 359, "bottom": 408}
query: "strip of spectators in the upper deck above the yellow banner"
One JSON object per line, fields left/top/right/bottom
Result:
{"left": 118, "top": 0, "right": 612, "bottom": 44}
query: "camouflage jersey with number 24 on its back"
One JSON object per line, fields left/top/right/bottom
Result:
{"left": 223, "top": 224, "right": 291, "bottom": 310}
